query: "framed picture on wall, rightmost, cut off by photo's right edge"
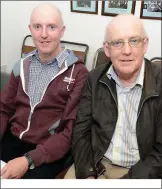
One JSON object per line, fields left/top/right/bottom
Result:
{"left": 140, "top": 0, "right": 162, "bottom": 20}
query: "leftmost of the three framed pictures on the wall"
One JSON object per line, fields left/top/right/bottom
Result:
{"left": 70, "top": 0, "right": 98, "bottom": 14}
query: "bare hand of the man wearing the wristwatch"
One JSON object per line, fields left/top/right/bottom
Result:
{"left": 1, "top": 157, "right": 28, "bottom": 179}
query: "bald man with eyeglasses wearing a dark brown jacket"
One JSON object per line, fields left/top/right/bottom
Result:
{"left": 65, "top": 14, "right": 162, "bottom": 179}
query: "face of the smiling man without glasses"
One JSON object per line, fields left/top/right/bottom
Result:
{"left": 29, "top": 11, "right": 65, "bottom": 57}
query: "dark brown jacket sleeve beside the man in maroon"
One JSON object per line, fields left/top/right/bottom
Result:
{"left": 72, "top": 73, "right": 97, "bottom": 179}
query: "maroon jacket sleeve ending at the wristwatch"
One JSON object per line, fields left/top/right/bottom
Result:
{"left": 29, "top": 65, "right": 88, "bottom": 167}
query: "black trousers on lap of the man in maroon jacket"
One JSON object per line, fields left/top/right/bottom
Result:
{"left": 1, "top": 129, "right": 70, "bottom": 179}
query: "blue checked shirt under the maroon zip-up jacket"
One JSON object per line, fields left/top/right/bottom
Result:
{"left": 28, "top": 49, "right": 69, "bottom": 107}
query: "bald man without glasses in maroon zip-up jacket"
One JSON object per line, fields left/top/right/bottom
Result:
{"left": 0, "top": 3, "right": 87, "bottom": 179}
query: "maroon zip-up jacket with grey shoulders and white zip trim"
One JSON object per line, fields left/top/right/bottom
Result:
{"left": 0, "top": 51, "right": 88, "bottom": 166}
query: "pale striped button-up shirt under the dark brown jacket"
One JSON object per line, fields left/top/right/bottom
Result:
{"left": 105, "top": 62, "right": 145, "bottom": 168}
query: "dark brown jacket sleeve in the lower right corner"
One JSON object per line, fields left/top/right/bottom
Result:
{"left": 122, "top": 100, "right": 162, "bottom": 179}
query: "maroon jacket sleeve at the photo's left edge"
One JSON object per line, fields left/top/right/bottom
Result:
{"left": 0, "top": 72, "right": 19, "bottom": 141}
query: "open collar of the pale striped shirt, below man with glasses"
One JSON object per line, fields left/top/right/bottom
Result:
{"left": 106, "top": 60, "right": 145, "bottom": 88}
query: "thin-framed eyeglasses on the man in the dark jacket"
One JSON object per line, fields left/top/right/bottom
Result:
{"left": 106, "top": 37, "right": 147, "bottom": 49}
